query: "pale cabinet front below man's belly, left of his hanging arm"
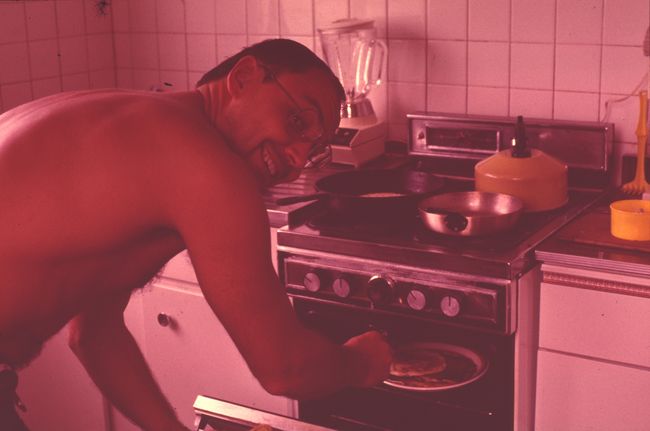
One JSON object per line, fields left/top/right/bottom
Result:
{"left": 16, "top": 328, "right": 106, "bottom": 430}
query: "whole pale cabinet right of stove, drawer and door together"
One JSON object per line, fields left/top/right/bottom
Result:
{"left": 535, "top": 265, "right": 650, "bottom": 431}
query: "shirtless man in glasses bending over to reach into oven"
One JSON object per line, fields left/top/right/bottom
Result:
{"left": 0, "top": 40, "right": 391, "bottom": 431}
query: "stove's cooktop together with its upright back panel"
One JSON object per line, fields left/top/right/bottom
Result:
{"left": 277, "top": 114, "right": 613, "bottom": 280}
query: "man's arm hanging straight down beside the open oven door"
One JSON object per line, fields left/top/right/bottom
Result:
{"left": 69, "top": 293, "right": 187, "bottom": 431}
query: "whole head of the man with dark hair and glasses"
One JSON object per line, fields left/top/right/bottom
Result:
{"left": 197, "top": 39, "right": 345, "bottom": 185}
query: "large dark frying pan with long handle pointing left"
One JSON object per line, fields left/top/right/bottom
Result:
{"left": 276, "top": 169, "right": 443, "bottom": 214}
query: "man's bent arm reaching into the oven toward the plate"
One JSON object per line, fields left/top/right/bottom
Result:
{"left": 165, "top": 151, "right": 391, "bottom": 398}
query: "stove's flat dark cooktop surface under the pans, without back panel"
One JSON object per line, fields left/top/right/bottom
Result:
{"left": 278, "top": 186, "right": 601, "bottom": 279}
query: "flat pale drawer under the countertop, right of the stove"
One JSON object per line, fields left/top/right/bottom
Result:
{"left": 539, "top": 282, "right": 650, "bottom": 368}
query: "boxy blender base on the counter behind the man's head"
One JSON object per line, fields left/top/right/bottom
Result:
{"left": 332, "top": 119, "right": 386, "bottom": 167}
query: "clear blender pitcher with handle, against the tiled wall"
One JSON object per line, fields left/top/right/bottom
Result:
{"left": 318, "top": 18, "right": 387, "bottom": 122}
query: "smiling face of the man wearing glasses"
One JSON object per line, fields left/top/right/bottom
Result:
{"left": 229, "top": 65, "right": 340, "bottom": 187}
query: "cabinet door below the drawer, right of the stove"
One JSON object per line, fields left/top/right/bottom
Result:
{"left": 535, "top": 350, "right": 650, "bottom": 431}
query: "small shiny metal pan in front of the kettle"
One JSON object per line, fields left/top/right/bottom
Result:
{"left": 418, "top": 191, "right": 524, "bottom": 236}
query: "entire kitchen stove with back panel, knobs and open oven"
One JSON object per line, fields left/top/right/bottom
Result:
{"left": 277, "top": 113, "right": 613, "bottom": 431}
